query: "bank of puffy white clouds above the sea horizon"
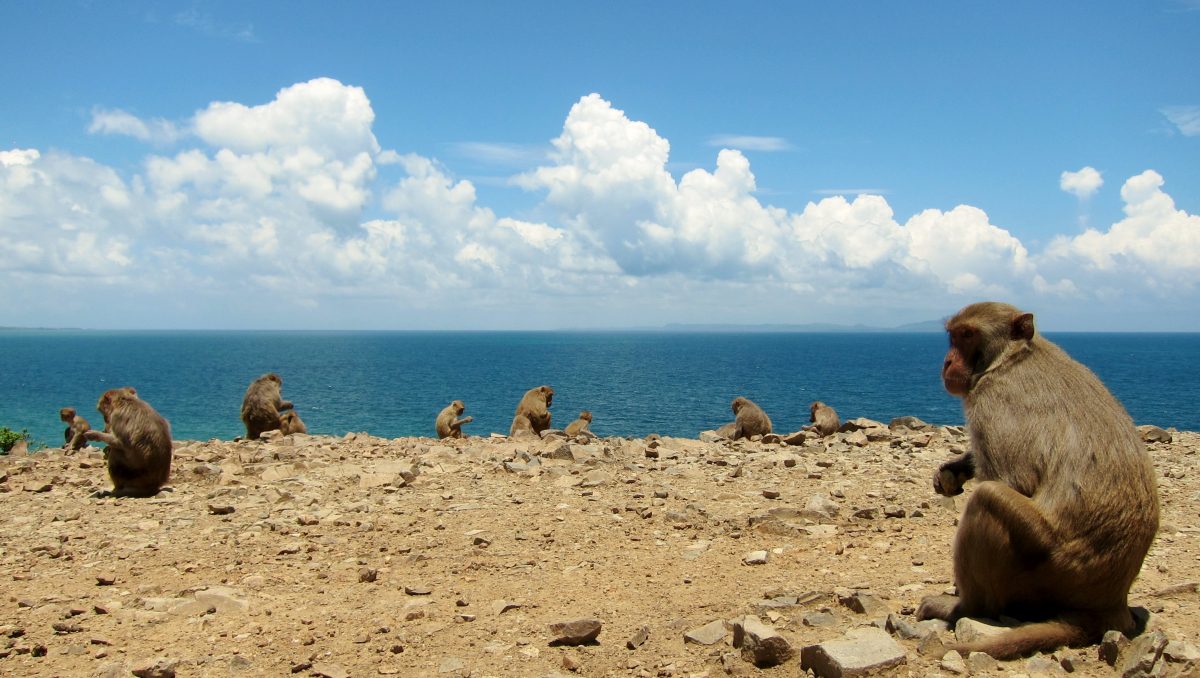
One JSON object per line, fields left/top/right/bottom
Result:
{"left": 0, "top": 78, "right": 1200, "bottom": 328}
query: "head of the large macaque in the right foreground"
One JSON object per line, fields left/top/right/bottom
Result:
{"left": 942, "top": 301, "right": 1036, "bottom": 397}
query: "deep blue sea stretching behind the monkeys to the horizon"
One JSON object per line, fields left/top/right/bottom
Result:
{"left": 0, "top": 330, "right": 1200, "bottom": 445}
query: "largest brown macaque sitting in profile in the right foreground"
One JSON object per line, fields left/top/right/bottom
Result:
{"left": 917, "top": 302, "right": 1158, "bottom": 659}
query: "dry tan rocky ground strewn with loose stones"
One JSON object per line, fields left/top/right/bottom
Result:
{"left": 0, "top": 421, "right": 1200, "bottom": 678}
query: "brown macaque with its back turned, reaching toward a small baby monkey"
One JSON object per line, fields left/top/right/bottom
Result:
{"left": 84, "top": 388, "right": 172, "bottom": 497}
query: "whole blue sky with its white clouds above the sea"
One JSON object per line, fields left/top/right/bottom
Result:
{"left": 0, "top": 0, "right": 1200, "bottom": 331}
